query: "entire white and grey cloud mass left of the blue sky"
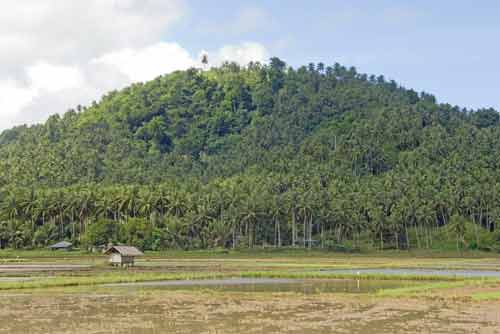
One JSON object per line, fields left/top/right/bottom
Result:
{"left": 0, "top": 0, "right": 268, "bottom": 131}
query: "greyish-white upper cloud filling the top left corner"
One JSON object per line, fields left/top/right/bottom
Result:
{"left": 0, "top": 0, "right": 185, "bottom": 75}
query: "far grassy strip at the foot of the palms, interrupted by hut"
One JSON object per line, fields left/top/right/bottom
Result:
{"left": 6, "top": 249, "right": 500, "bottom": 272}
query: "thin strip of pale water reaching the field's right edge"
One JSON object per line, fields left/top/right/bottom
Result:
{"left": 321, "top": 268, "right": 500, "bottom": 278}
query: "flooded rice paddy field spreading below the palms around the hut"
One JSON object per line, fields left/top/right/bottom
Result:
{"left": 0, "top": 250, "right": 500, "bottom": 334}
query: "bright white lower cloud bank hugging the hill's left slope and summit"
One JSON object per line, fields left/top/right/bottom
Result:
{"left": 0, "top": 42, "right": 268, "bottom": 130}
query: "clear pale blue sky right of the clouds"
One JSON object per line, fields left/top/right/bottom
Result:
{"left": 173, "top": 0, "right": 500, "bottom": 109}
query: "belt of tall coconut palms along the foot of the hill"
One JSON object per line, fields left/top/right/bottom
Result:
{"left": 0, "top": 170, "right": 500, "bottom": 250}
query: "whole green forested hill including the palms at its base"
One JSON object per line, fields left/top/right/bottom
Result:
{"left": 0, "top": 58, "right": 500, "bottom": 249}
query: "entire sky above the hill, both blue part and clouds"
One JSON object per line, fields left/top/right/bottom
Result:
{"left": 0, "top": 0, "right": 500, "bottom": 130}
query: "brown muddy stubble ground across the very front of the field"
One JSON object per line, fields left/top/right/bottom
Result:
{"left": 0, "top": 288, "right": 500, "bottom": 334}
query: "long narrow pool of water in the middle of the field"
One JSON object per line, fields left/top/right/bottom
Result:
{"left": 105, "top": 278, "right": 416, "bottom": 294}
